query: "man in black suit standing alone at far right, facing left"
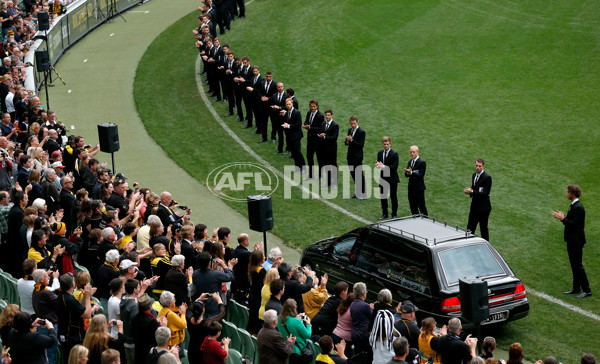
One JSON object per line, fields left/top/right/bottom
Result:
{"left": 552, "top": 185, "right": 592, "bottom": 298}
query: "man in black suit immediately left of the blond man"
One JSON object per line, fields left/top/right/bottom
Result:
{"left": 375, "top": 136, "right": 400, "bottom": 220}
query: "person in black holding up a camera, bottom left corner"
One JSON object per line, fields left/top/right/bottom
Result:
{"left": 6, "top": 312, "right": 56, "bottom": 364}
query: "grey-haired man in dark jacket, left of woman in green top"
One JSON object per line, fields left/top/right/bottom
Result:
{"left": 256, "top": 310, "right": 296, "bottom": 364}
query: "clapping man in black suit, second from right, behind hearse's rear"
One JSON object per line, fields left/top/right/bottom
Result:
{"left": 463, "top": 158, "right": 492, "bottom": 241}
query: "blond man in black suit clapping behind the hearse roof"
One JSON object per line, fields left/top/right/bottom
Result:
{"left": 404, "top": 145, "right": 427, "bottom": 216}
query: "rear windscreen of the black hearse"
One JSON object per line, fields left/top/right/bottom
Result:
{"left": 438, "top": 244, "right": 506, "bottom": 286}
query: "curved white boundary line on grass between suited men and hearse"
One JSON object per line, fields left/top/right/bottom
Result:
{"left": 196, "top": 56, "right": 372, "bottom": 224}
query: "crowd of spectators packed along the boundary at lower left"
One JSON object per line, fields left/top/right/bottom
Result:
{"left": 0, "top": 0, "right": 595, "bottom": 364}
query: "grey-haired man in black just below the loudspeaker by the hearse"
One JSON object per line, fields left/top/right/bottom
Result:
{"left": 431, "top": 317, "right": 477, "bottom": 364}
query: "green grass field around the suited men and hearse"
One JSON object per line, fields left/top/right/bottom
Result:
{"left": 134, "top": 0, "right": 600, "bottom": 363}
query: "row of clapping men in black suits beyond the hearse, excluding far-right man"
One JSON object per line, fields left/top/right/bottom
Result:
{"left": 197, "top": 23, "right": 491, "bottom": 230}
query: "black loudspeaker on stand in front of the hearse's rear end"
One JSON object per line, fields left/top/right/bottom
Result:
{"left": 458, "top": 279, "right": 490, "bottom": 348}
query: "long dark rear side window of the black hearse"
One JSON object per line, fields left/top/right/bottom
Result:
{"left": 357, "top": 233, "right": 429, "bottom": 293}
